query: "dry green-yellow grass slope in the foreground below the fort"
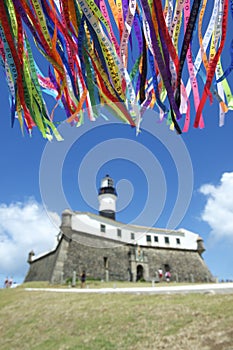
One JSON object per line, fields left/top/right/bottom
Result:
{"left": 0, "top": 282, "right": 233, "bottom": 350}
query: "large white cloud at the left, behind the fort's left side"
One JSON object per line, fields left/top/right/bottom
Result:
{"left": 0, "top": 199, "right": 60, "bottom": 279}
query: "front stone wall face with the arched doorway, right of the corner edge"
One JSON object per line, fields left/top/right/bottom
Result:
{"left": 61, "top": 232, "right": 213, "bottom": 282}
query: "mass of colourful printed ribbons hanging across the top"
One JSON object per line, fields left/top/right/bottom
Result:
{"left": 0, "top": 0, "right": 233, "bottom": 140}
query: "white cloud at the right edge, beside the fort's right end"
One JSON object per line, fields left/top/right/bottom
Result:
{"left": 200, "top": 173, "right": 233, "bottom": 240}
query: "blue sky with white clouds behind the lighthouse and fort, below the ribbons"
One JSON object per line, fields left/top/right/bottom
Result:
{"left": 0, "top": 2, "right": 233, "bottom": 286}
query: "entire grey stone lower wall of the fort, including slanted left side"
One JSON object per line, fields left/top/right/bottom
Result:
{"left": 25, "top": 228, "right": 213, "bottom": 283}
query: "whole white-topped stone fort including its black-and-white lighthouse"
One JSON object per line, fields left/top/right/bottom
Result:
{"left": 25, "top": 175, "right": 213, "bottom": 283}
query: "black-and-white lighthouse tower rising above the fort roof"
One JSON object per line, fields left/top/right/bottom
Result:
{"left": 98, "top": 175, "right": 117, "bottom": 220}
